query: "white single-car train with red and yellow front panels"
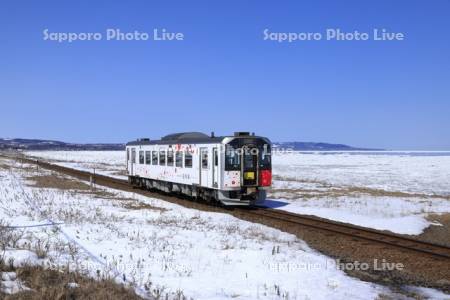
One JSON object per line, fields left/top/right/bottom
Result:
{"left": 126, "top": 132, "right": 272, "bottom": 206}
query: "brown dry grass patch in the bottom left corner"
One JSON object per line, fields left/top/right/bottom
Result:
{"left": 0, "top": 266, "right": 142, "bottom": 300}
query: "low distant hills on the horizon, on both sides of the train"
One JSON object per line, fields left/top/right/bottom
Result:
{"left": 0, "top": 138, "right": 381, "bottom": 151}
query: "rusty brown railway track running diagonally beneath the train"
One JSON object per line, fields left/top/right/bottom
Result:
{"left": 6, "top": 157, "right": 450, "bottom": 262}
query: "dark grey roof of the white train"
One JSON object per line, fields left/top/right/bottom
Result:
{"left": 127, "top": 132, "right": 268, "bottom": 146}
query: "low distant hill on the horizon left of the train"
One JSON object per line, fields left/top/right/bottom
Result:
{"left": 0, "top": 138, "right": 125, "bottom": 150}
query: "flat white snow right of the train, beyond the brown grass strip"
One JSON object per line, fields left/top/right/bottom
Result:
{"left": 273, "top": 151, "right": 450, "bottom": 196}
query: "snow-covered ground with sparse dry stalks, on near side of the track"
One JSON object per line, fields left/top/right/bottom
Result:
{"left": 0, "top": 159, "right": 398, "bottom": 299}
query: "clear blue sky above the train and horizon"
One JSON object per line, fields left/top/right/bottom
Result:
{"left": 0, "top": 0, "right": 450, "bottom": 150}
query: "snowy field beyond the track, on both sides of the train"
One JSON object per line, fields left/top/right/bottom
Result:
{"left": 27, "top": 151, "right": 450, "bottom": 235}
